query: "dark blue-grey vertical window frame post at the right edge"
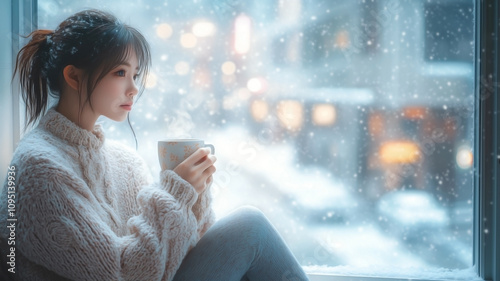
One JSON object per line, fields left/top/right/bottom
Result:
{"left": 474, "top": 0, "right": 500, "bottom": 281}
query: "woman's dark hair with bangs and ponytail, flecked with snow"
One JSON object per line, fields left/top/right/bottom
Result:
{"left": 13, "top": 10, "right": 151, "bottom": 127}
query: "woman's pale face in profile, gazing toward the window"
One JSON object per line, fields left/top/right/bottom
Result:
{"left": 91, "top": 50, "right": 139, "bottom": 121}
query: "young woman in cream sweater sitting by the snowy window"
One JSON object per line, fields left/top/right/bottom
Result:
{"left": 0, "top": 10, "right": 307, "bottom": 281}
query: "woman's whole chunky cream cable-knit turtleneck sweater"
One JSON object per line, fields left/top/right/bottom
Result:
{"left": 0, "top": 109, "right": 214, "bottom": 281}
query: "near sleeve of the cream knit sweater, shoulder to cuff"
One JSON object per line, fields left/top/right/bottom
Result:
{"left": 9, "top": 155, "right": 199, "bottom": 281}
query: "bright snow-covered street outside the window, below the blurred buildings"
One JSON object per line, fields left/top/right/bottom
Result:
{"left": 208, "top": 128, "right": 471, "bottom": 268}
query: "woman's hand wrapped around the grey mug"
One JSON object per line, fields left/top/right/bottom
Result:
{"left": 174, "top": 148, "right": 217, "bottom": 194}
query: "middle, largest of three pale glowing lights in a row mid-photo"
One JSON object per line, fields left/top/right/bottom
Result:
{"left": 276, "top": 100, "right": 304, "bottom": 132}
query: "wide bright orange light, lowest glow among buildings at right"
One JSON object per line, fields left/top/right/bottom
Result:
{"left": 379, "top": 141, "right": 420, "bottom": 164}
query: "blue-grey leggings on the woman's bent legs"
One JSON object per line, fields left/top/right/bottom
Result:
{"left": 174, "top": 207, "right": 308, "bottom": 281}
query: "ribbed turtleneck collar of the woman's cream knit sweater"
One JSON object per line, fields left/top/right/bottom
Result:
{"left": 39, "top": 108, "right": 104, "bottom": 149}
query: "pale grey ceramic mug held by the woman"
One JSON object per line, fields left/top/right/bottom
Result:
{"left": 158, "top": 139, "right": 215, "bottom": 170}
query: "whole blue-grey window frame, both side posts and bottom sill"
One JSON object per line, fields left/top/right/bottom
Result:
{"left": 2, "top": 0, "right": 500, "bottom": 281}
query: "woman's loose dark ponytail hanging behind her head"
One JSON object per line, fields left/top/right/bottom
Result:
{"left": 12, "top": 29, "right": 53, "bottom": 126}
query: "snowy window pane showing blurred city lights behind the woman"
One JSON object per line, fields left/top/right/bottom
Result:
{"left": 38, "top": 0, "right": 475, "bottom": 278}
